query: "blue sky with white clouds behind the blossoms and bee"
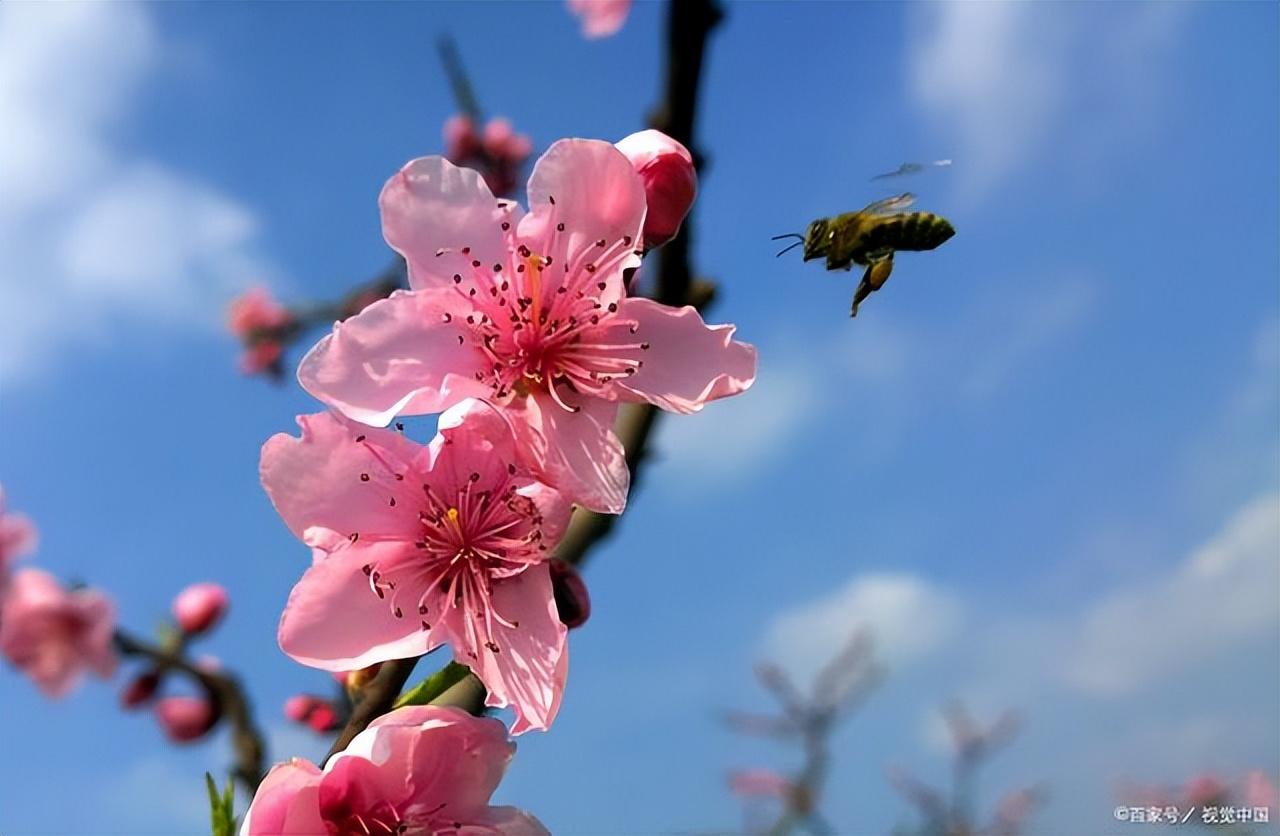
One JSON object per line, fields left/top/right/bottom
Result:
{"left": 0, "top": 3, "right": 1280, "bottom": 833}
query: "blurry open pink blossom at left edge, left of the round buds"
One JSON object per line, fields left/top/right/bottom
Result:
{"left": 0, "top": 568, "right": 116, "bottom": 698}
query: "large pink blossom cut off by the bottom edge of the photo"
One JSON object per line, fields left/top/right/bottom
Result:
{"left": 241, "top": 705, "right": 547, "bottom": 836}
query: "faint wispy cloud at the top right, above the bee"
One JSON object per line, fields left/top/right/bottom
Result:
{"left": 908, "top": 3, "right": 1189, "bottom": 198}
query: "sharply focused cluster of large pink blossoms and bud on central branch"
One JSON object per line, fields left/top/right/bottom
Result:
{"left": 244, "top": 131, "right": 755, "bottom": 819}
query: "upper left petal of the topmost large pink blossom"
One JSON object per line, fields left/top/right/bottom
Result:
{"left": 378, "top": 156, "right": 520, "bottom": 289}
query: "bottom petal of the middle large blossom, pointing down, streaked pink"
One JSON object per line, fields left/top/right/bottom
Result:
{"left": 454, "top": 563, "right": 568, "bottom": 735}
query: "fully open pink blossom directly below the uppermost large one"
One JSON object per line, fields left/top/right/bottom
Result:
{"left": 261, "top": 401, "right": 570, "bottom": 734}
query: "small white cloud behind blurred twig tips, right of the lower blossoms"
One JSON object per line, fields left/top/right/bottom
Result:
{"left": 764, "top": 572, "right": 961, "bottom": 681}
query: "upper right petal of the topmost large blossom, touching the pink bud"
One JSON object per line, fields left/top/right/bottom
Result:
{"left": 520, "top": 140, "right": 645, "bottom": 303}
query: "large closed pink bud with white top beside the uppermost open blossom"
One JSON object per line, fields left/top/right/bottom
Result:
{"left": 617, "top": 128, "right": 698, "bottom": 250}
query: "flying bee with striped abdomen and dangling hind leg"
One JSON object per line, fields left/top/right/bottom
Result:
{"left": 773, "top": 193, "right": 956, "bottom": 316}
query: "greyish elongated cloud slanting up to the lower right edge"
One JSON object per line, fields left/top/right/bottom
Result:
{"left": 1064, "top": 494, "right": 1280, "bottom": 696}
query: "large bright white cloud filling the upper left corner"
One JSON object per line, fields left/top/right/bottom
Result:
{"left": 0, "top": 4, "right": 273, "bottom": 383}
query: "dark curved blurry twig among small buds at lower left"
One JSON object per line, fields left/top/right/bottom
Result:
{"left": 114, "top": 627, "right": 266, "bottom": 795}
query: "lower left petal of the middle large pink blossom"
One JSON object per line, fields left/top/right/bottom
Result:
{"left": 278, "top": 542, "right": 440, "bottom": 671}
